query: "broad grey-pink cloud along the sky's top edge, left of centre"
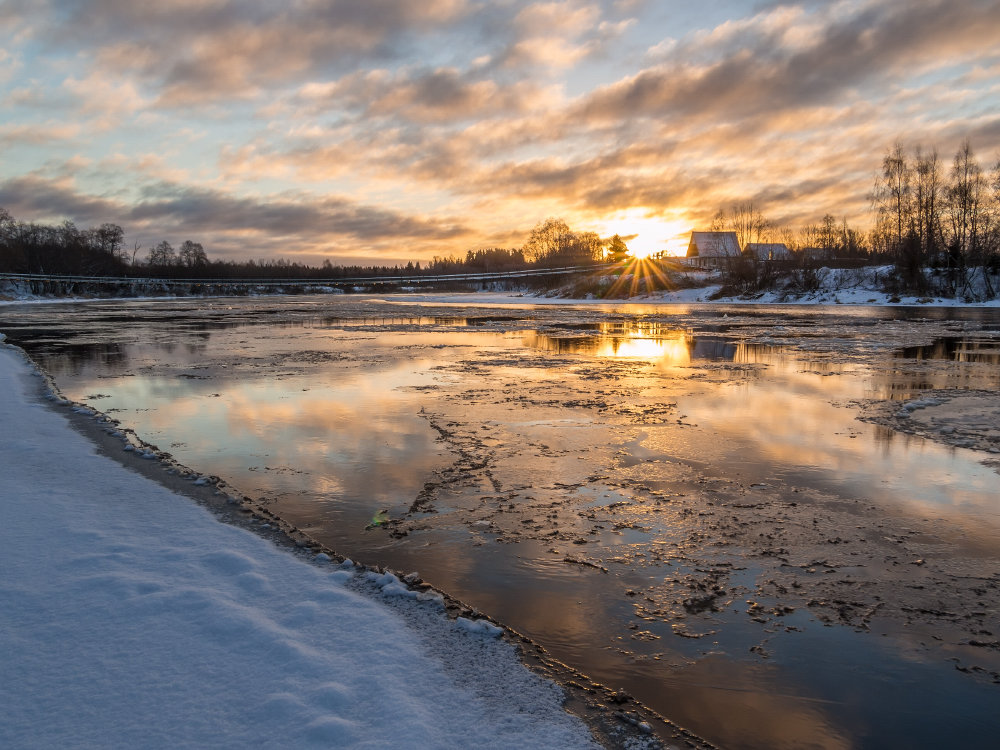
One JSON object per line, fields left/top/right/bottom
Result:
{"left": 21, "top": 0, "right": 478, "bottom": 107}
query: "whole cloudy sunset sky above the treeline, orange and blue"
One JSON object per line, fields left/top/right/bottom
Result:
{"left": 0, "top": 0, "right": 1000, "bottom": 265}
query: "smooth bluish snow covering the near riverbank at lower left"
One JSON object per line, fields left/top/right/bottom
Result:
{"left": 0, "top": 345, "right": 595, "bottom": 750}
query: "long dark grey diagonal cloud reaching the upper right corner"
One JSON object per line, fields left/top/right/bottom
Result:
{"left": 577, "top": 0, "right": 1000, "bottom": 122}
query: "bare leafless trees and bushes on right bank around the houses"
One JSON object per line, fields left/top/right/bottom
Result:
{"left": 711, "top": 140, "right": 1000, "bottom": 299}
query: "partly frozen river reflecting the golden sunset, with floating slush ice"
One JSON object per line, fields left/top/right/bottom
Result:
{"left": 0, "top": 296, "right": 1000, "bottom": 748}
